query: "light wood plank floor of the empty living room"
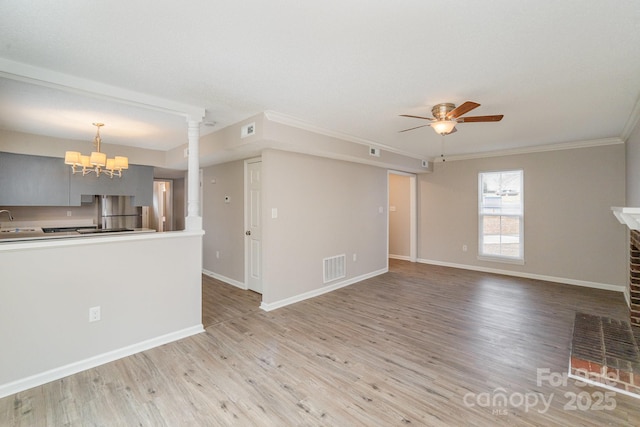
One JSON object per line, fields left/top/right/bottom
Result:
{"left": 0, "top": 260, "right": 640, "bottom": 426}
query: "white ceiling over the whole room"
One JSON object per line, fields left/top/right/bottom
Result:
{"left": 0, "top": 0, "right": 640, "bottom": 162}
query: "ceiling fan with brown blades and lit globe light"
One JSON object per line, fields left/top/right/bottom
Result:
{"left": 400, "top": 101, "right": 504, "bottom": 135}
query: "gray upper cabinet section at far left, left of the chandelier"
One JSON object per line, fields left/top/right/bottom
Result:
{"left": 0, "top": 153, "right": 70, "bottom": 206}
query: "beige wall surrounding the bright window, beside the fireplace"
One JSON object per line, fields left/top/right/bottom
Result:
{"left": 418, "top": 144, "right": 627, "bottom": 286}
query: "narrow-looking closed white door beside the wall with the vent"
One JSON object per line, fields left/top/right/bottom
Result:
{"left": 245, "top": 159, "right": 262, "bottom": 294}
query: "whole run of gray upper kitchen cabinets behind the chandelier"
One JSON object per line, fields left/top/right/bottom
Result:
{"left": 0, "top": 152, "right": 153, "bottom": 206}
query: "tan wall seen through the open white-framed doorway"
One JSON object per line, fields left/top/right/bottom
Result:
{"left": 389, "top": 173, "right": 411, "bottom": 259}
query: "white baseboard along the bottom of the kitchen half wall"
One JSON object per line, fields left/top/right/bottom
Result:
{"left": 0, "top": 324, "right": 204, "bottom": 398}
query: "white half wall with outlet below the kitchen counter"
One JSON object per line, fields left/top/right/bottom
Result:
{"left": 0, "top": 230, "right": 204, "bottom": 397}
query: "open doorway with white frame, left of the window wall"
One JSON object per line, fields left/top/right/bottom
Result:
{"left": 387, "top": 171, "right": 418, "bottom": 262}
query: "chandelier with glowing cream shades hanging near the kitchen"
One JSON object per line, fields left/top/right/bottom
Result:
{"left": 64, "top": 123, "right": 129, "bottom": 178}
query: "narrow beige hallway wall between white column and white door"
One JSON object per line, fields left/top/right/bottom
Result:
{"left": 202, "top": 160, "right": 244, "bottom": 283}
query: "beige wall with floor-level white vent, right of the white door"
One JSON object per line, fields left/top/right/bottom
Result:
{"left": 262, "top": 150, "right": 388, "bottom": 304}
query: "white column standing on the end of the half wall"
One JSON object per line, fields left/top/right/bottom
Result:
{"left": 185, "top": 117, "right": 202, "bottom": 230}
